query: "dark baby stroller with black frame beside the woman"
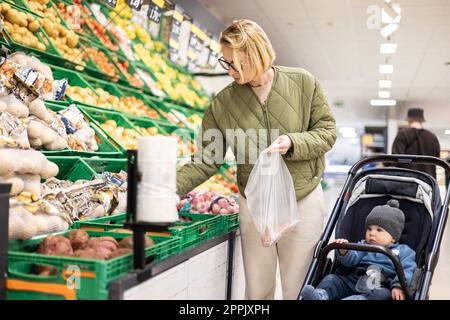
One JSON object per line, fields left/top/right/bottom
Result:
{"left": 298, "top": 155, "right": 450, "bottom": 300}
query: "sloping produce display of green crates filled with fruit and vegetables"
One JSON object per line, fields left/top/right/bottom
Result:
{"left": 0, "top": 0, "right": 239, "bottom": 299}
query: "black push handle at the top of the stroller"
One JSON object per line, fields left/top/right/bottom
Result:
{"left": 349, "top": 154, "right": 450, "bottom": 176}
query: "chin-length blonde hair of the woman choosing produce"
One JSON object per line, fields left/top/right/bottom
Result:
{"left": 220, "top": 19, "right": 275, "bottom": 79}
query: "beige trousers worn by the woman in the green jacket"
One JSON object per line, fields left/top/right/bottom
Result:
{"left": 239, "top": 184, "right": 327, "bottom": 300}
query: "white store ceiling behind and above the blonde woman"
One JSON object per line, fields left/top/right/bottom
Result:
{"left": 199, "top": 0, "right": 450, "bottom": 133}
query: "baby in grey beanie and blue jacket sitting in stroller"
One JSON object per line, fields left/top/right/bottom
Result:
{"left": 301, "top": 199, "right": 416, "bottom": 300}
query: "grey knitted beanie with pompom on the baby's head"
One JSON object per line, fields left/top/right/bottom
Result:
{"left": 365, "top": 199, "right": 405, "bottom": 242}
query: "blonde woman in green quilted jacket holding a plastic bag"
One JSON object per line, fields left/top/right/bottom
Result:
{"left": 177, "top": 20, "right": 336, "bottom": 299}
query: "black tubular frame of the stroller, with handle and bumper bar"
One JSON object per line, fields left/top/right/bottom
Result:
{"left": 298, "top": 155, "right": 450, "bottom": 300}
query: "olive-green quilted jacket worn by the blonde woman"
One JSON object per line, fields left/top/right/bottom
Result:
{"left": 177, "top": 66, "right": 336, "bottom": 200}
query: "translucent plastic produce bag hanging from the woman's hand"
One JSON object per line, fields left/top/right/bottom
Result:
{"left": 244, "top": 151, "right": 298, "bottom": 247}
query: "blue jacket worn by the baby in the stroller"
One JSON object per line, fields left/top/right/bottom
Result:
{"left": 338, "top": 240, "right": 417, "bottom": 288}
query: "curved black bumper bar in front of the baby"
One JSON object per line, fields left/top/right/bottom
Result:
{"left": 313, "top": 242, "right": 412, "bottom": 300}
